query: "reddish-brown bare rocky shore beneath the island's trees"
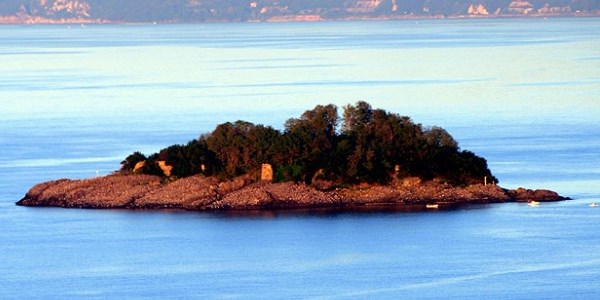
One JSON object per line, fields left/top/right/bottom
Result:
{"left": 17, "top": 174, "right": 569, "bottom": 211}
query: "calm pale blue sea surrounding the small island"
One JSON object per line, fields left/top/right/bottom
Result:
{"left": 0, "top": 18, "right": 600, "bottom": 299}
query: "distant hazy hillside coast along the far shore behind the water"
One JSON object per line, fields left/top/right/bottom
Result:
{"left": 0, "top": 0, "right": 600, "bottom": 24}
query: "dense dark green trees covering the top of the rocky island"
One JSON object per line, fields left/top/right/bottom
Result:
{"left": 121, "top": 101, "right": 497, "bottom": 185}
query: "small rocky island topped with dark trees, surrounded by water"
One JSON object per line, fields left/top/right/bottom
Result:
{"left": 17, "top": 101, "right": 569, "bottom": 211}
